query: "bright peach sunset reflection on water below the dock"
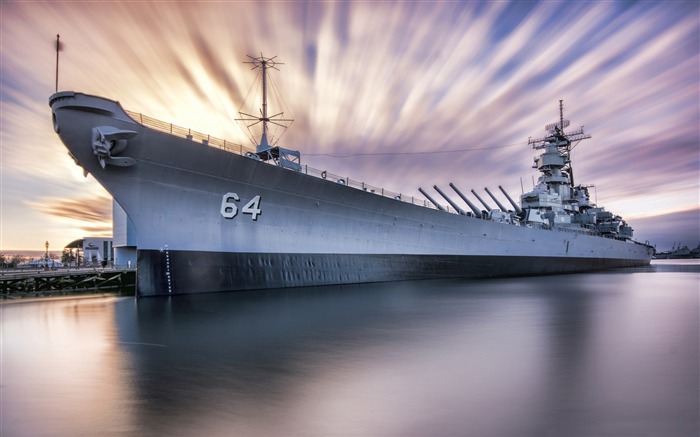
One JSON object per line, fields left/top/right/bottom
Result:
{"left": 0, "top": 298, "right": 133, "bottom": 436}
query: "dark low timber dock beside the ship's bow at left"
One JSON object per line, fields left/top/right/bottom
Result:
{"left": 0, "top": 268, "right": 136, "bottom": 299}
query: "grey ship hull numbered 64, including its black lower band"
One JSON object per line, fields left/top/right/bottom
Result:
{"left": 50, "top": 92, "right": 653, "bottom": 296}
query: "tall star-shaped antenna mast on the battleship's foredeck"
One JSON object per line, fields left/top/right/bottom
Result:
{"left": 235, "top": 53, "right": 294, "bottom": 152}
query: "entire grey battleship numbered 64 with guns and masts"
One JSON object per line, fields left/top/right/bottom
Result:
{"left": 49, "top": 55, "right": 654, "bottom": 297}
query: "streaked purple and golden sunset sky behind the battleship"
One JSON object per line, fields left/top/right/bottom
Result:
{"left": 0, "top": 0, "right": 700, "bottom": 254}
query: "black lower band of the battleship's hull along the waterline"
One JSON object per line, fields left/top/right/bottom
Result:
{"left": 137, "top": 249, "right": 649, "bottom": 296}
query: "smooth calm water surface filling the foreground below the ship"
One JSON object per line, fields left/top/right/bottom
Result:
{"left": 0, "top": 261, "right": 700, "bottom": 437}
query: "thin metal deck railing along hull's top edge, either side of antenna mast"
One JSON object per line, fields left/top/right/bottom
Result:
{"left": 126, "top": 110, "right": 442, "bottom": 213}
